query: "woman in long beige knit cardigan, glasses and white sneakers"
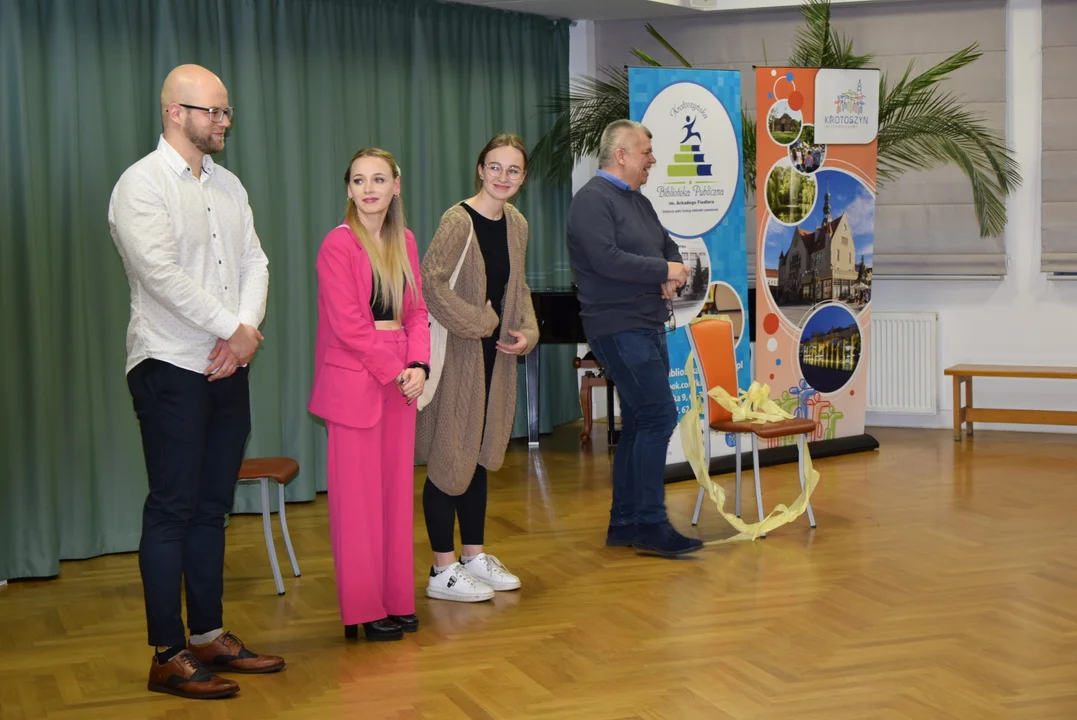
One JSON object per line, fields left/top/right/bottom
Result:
{"left": 416, "top": 135, "right": 539, "bottom": 602}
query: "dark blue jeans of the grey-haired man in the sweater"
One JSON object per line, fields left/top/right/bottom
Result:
{"left": 588, "top": 329, "right": 677, "bottom": 526}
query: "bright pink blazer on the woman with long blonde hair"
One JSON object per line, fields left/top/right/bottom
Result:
{"left": 307, "top": 225, "right": 430, "bottom": 427}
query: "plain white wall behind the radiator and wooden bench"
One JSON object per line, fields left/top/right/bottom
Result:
{"left": 569, "top": 0, "right": 1077, "bottom": 432}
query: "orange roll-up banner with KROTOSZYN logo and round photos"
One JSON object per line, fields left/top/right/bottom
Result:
{"left": 755, "top": 68, "right": 879, "bottom": 448}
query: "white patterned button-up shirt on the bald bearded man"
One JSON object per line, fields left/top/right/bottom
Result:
{"left": 109, "top": 136, "right": 269, "bottom": 373}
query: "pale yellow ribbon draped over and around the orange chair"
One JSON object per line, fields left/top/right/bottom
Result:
{"left": 679, "top": 340, "right": 819, "bottom": 545}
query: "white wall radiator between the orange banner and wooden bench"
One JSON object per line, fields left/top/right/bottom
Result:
{"left": 867, "top": 312, "right": 938, "bottom": 415}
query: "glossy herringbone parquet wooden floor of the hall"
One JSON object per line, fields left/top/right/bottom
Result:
{"left": 0, "top": 426, "right": 1077, "bottom": 720}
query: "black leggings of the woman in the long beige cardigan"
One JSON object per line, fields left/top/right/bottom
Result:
{"left": 422, "top": 330, "right": 500, "bottom": 552}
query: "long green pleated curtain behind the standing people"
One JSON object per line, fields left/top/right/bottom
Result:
{"left": 0, "top": 0, "right": 579, "bottom": 578}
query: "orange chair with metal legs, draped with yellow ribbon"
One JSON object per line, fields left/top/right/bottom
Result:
{"left": 688, "top": 317, "right": 815, "bottom": 537}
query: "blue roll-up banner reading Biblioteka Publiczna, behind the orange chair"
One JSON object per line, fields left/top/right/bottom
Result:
{"left": 628, "top": 68, "right": 751, "bottom": 464}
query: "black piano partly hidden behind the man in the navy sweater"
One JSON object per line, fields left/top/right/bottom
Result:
{"left": 523, "top": 285, "right": 755, "bottom": 446}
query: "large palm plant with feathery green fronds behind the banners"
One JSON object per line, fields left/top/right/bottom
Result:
{"left": 532, "top": 0, "right": 1021, "bottom": 237}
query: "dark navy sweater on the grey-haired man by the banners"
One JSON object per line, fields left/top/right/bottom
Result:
{"left": 569, "top": 175, "right": 682, "bottom": 338}
